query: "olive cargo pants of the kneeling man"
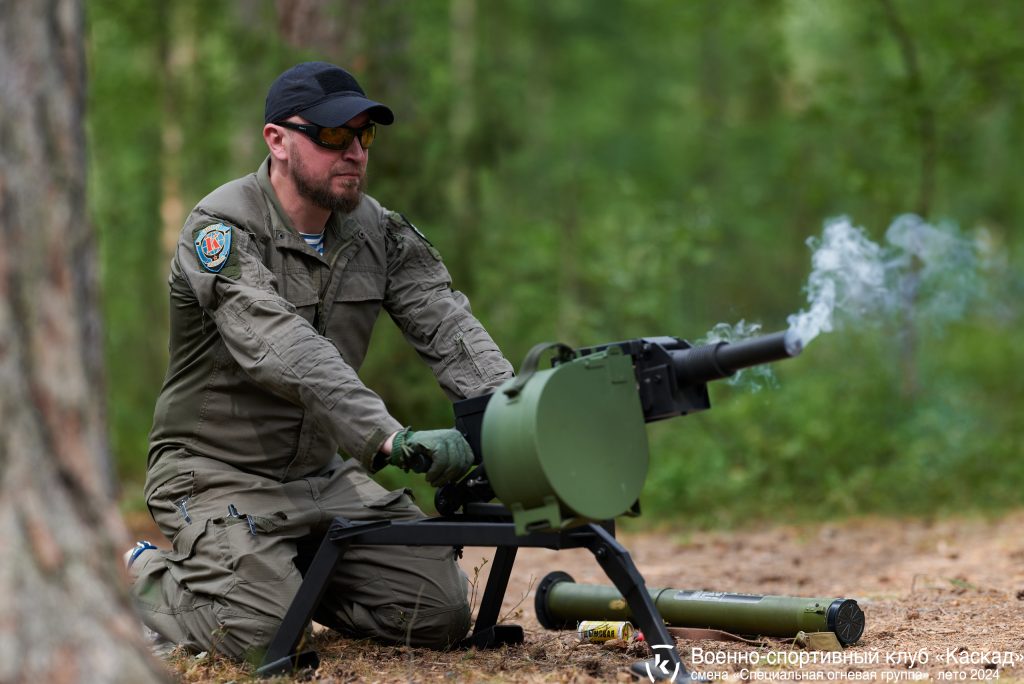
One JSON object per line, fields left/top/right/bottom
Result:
{"left": 131, "top": 454, "right": 470, "bottom": 658}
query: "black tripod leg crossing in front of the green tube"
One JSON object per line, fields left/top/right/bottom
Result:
{"left": 587, "top": 523, "right": 689, "bottom": 682}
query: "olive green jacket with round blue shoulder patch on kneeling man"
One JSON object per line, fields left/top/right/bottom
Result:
{"left": 150, "top": 158, "right": 512, "bottom": 480}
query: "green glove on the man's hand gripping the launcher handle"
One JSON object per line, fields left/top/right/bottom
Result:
{"left": 390, "top": 428, "right": 473, "bottom": 486}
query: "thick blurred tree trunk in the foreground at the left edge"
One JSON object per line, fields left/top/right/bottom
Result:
{"left": 0, "top": 0, "right": 167, "bottom": 682}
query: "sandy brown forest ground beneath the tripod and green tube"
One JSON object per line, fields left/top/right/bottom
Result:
{"left": 128, "top": 511, "right": 1024, "bottom": 682}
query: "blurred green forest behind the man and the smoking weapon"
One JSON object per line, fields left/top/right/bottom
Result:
{"left": 87, "top": 0, "right": 1024, "bottom": 526}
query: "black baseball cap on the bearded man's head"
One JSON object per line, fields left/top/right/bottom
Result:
{"left": 264, "top": 61, "right": 394, "bottom": 126}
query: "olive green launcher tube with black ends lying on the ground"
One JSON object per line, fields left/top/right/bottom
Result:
{"left": 535, "top": 572, "right": 864, "bottom": 646}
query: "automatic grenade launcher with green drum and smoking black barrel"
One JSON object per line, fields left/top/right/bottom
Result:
{"left": 434, "top": 331, "right": 803, "bottom": 535}
